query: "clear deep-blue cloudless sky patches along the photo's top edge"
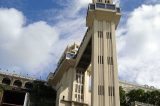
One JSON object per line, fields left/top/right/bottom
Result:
{"left": 0, "top": 0, "right": 147, "bottom": 24}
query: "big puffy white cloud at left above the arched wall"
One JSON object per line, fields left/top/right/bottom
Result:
{"left": 0, "top": 8, "right": 59, "bottom": 73}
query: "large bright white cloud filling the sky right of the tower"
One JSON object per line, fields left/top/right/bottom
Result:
{"left": 117, "top": 5, "right": 160, "bottom": 87}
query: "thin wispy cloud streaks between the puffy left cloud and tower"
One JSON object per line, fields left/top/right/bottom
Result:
{"left": 43, "top": 0, "right": 91, "bottom": 59}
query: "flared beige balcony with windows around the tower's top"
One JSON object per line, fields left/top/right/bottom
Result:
{"left": 86, "top": 3, "right": 121, "bottom": 28}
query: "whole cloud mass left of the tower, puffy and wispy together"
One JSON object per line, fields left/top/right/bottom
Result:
{"left": 0, "top": 0, "right": 91, "bottom": 77}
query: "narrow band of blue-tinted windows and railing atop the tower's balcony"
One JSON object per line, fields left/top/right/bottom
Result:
{"left": 88, "top": 3, "right": 120, "bottom": 13}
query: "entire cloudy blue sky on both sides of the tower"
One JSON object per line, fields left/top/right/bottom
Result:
{"left": 0, "top": 0, "right": 160, "bottom": 87}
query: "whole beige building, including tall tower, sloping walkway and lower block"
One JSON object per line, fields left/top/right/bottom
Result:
{"left": 49, "top": 0, "right": 121, "bottom": 106}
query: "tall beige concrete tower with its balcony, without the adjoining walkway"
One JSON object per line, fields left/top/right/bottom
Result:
{"left": 86, "top": 0, "right": 121, "bottom": 106}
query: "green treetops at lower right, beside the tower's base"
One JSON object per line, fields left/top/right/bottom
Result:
{"left": 119, "top": 87, "right": 160, "bottom": 106}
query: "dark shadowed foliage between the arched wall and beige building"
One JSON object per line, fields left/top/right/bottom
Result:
{"left": 30, "top": 81, "right": 56, "bottom": 106}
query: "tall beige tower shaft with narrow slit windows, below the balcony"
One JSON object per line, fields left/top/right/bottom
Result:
{"left": 92, "top": 19, "right": 120, "bottom": 106}
